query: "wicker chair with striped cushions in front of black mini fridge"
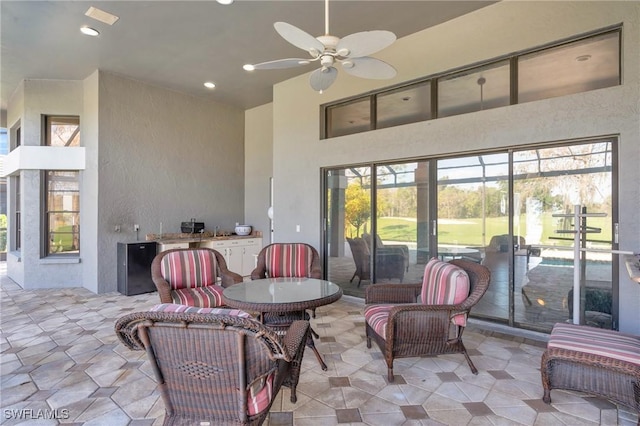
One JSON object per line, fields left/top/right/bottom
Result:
{"left": 151, "top": 248, "right": 242, "bottom": 308}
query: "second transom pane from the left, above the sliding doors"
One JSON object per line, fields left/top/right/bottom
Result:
{"left": 376, "top": 81, "right": 431, "bottom": 129}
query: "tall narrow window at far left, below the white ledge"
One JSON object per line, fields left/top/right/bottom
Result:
{"left": 44, "top": 170, "right": 80, "bottom": 256}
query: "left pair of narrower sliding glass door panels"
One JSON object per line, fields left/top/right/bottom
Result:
{"left": 325, "top": 161, "right": 431, "bottom": 297}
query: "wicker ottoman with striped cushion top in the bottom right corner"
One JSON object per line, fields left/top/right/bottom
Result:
{"left": 541, "top": 323, "right": 640, "bottom": 424}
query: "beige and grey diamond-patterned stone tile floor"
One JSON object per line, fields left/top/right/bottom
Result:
{"left": 0, "top": 264, "right": 637, "bottom": 426}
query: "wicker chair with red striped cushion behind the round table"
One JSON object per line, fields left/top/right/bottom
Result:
{"left": 251, "top": 243, "right": 322, "bottom": 318}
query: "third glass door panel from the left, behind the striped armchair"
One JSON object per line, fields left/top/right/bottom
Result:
{"left": 432, "top": 153, "right": 512, "bottom": 321}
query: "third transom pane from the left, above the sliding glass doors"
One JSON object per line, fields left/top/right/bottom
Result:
{"left": 438, "top": 60, "right": 511, "bottom": 118}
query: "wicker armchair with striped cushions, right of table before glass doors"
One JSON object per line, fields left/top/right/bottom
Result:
{"left": 364, "top": 258, "right": 491, "bottom": 382}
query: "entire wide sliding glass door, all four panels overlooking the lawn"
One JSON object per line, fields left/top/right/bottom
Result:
{"left": 324, "top": 138, "right": 618, "bottom": 331}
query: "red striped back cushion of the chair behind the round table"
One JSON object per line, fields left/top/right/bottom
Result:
{"left": 265, "top": 243, "right": 313, "bottom": 278}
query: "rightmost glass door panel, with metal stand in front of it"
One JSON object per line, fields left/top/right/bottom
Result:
{"left": 513, "top": 140, "right": 615, "bottom": 330}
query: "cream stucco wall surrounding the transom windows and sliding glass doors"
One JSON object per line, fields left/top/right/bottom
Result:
{"left": 273, "top": 1, "right": 640, "bottom": 334}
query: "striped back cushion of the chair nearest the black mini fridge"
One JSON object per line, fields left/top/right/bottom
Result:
{"left": 160, "top": 249, "right": 217, "bottom": 289}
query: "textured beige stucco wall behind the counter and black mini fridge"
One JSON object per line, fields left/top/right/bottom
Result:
{"left": 97, "top": 72, "right": 244, "bottom": 293}
